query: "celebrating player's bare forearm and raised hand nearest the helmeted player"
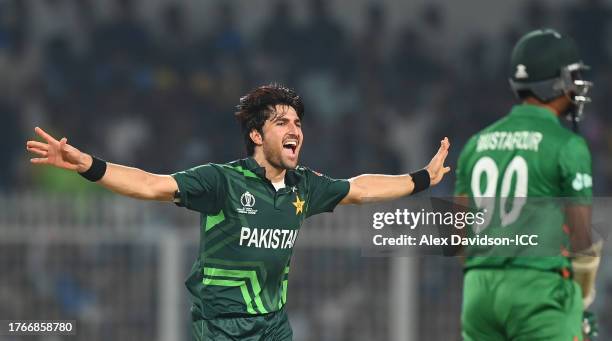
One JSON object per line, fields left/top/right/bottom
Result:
{"left": 340, "top": 137, "right": 450, "bottom": 205}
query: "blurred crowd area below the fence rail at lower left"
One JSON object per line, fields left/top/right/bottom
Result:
{"left": 0, "top": 242, "right": 160, "bottom": 341}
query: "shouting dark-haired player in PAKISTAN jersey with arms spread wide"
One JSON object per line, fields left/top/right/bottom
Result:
{"left": 27, "top": 85, "right": 450, "bottom": 341}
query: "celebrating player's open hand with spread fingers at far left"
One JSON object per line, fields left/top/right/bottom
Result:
{"left": 26, "top": 127, "right": 91, "bottom": 172}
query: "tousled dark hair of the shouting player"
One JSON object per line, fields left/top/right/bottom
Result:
{"left": 235, "top": 84, "right": 304, "bottom": 156}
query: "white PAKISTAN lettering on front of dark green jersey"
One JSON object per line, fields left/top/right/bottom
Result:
{"left": 240, "top": 227, "right": 298, "bottom": 249}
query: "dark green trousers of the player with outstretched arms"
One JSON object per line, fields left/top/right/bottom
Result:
{"left": 192, "top": 309, "right": 293, "bottom": 341}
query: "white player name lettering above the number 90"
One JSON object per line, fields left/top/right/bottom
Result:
{"left": 476, "top": 131, "right": 543, "bottom": 152}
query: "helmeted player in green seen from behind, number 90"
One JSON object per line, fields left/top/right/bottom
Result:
{"left": 455, "top": 29, "right": 600, "bottom": 341}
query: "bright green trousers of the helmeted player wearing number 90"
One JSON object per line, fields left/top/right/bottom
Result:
{"left": 461, "top": 268, "right": 583, "bottom": 341}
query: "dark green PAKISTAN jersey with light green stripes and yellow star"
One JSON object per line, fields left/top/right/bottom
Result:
{"left": 172, "top": 158, "right": 350, "bottom": 320}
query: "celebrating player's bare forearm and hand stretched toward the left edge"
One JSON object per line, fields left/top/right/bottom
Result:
{"left": 26, "top": 127, "right": 178, "bottom": 201}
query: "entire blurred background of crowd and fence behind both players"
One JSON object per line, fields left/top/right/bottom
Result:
{"left": 0, "top": 0, "right": 612, "bottom": 341}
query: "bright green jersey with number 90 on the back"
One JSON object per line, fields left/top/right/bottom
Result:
{"left": 455, "top": 104, "right": 592, "bottom": 270}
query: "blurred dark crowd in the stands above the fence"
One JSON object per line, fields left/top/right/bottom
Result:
{"left": 0, "top": 0, "right": 612, "bottom": 194}
